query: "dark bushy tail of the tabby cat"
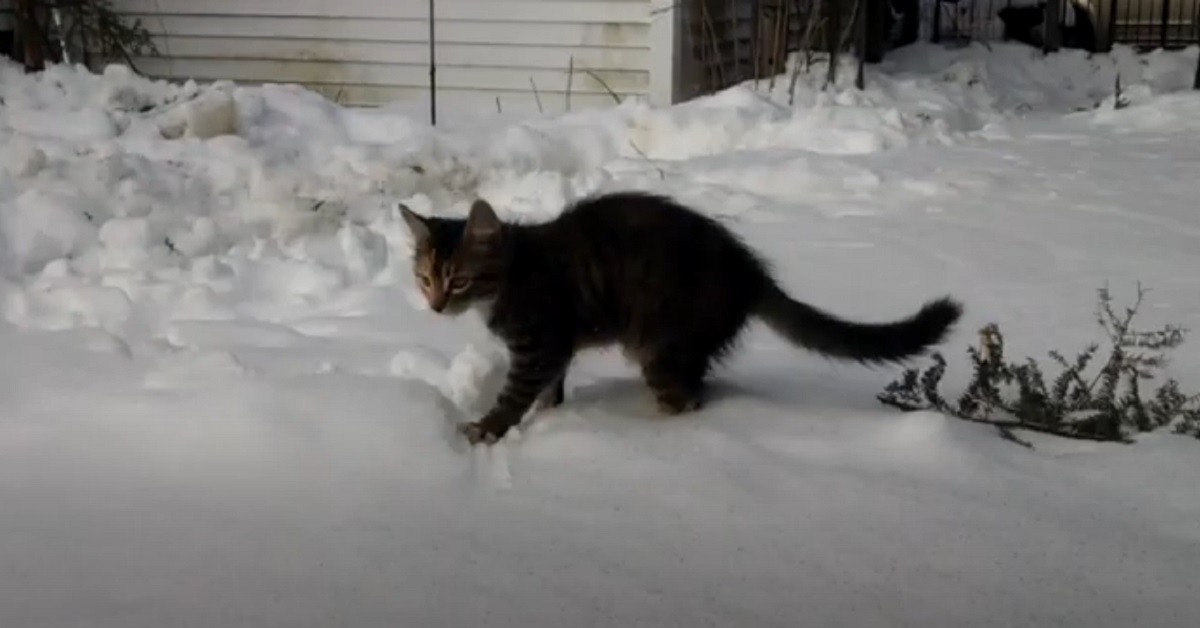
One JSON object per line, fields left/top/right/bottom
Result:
{"left": 756, "top": 283, "right": 962, "bottom": 363}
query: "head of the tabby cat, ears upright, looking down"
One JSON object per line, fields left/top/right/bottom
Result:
{"left": 400, "top": 199, "right": 504, "bottom": 316}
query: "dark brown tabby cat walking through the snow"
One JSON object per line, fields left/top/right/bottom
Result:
{"left": 400, "top": 192, "right": 962, "bottom": 444}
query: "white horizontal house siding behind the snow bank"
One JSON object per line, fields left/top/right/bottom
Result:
{"left": 114, "top": 0, "right": 674, "bottom": 112}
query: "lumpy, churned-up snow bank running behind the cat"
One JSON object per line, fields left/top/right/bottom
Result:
{"left": 0, "top": 44, "right": 1196, "bottom": 353}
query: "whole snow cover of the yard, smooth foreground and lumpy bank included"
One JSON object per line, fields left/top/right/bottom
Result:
{"left": 7, "top": 46, "right": 1200, "bottom": 628}
